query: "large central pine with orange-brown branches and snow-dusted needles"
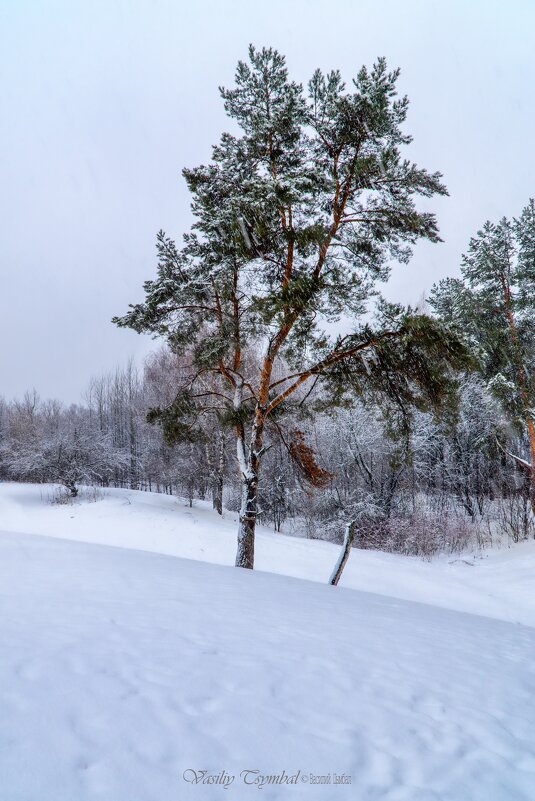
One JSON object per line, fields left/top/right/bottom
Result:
{"left": 114, "top": 47, "right": 464, "bottom": 568}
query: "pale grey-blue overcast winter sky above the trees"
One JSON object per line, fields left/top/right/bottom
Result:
{"left": 0, "top": 0, "right": 535, "bottom": 403}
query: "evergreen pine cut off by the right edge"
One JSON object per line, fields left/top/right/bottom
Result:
{"left": 430, "top": 200, "right": 535, "bottom": 513}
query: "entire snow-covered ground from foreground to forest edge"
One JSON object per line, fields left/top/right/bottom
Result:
{"left": 0, "top": 484, "right": 535, "bottom": 801}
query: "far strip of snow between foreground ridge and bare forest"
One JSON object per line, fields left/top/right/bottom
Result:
{"left": 0, "top": 483, "right": 535, "bottom": 626}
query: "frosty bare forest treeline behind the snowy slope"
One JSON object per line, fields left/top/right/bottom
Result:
{"left": 0, "top": 348, "right": 535, "bottom": 556}
